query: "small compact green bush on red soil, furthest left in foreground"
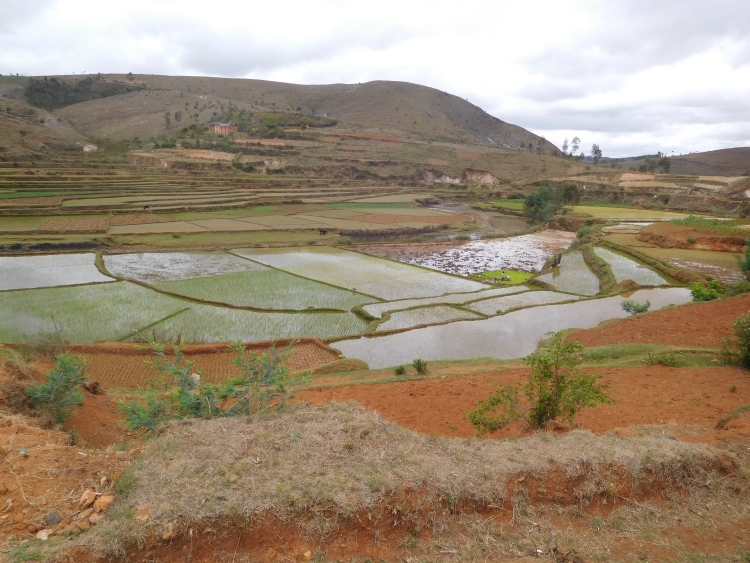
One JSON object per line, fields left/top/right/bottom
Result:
{"left": 28, "top": 353, "right": 86, "bottom": 424}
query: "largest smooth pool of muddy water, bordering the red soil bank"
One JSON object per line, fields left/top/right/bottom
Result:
{"left": 333, "top": 288, "right": 690, "bottom": 369}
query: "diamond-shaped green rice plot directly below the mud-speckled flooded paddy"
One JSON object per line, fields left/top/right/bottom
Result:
{"left": 155, "top": 270, "right": 372, "bottom": 311}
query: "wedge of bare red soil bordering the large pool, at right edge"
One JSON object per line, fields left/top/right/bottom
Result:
{"left": 571, "top": 294, "right": 750, "bottom": 347}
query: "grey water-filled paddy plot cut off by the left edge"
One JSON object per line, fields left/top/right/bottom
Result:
{"left": 0, "top": 253, "right": 114, "bottom": 294}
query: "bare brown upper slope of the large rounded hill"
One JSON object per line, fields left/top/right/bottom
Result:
{"left": 51, "top": 75, "right": 557, "bottom": 154}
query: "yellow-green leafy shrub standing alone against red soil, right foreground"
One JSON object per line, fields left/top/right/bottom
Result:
{"left": 466, "top": 332, "right": 614, "bottom": 435}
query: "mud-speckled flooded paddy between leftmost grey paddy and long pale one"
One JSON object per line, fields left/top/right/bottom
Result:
{"left": 104, "top": 252, "right": 266, "bottom": 283}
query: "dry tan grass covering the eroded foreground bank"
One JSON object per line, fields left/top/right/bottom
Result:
{"left": 64, "top": 403, "right": 736, "bottom": 556}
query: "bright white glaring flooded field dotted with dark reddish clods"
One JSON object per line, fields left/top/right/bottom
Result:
{"left": 395, "top": 230, "right": 576, "bottom": 276}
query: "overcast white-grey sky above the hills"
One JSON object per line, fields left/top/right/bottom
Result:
{"left": 0, "top": 0, "right": 750, "bottom": 157}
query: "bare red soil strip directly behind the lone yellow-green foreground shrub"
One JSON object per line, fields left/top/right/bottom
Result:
{"left": 298, "top": 365, "right": 750, "bottom": 441}
